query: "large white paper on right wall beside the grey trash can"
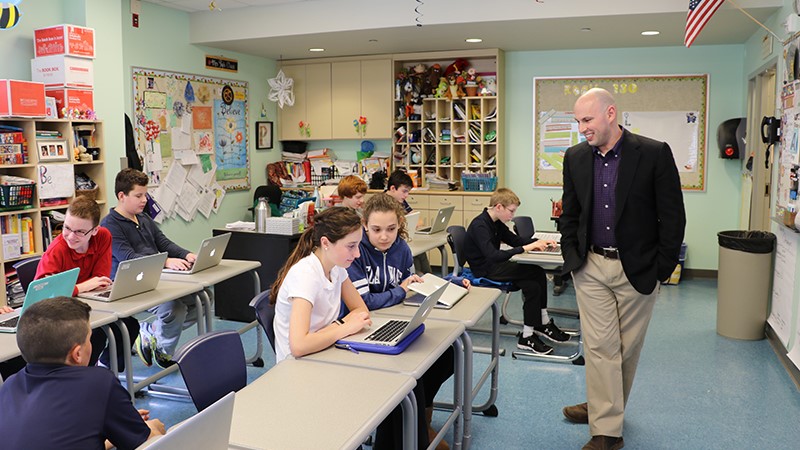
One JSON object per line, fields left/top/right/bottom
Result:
{"left": 767, "top": 226, "right": 800, "bottom": 347}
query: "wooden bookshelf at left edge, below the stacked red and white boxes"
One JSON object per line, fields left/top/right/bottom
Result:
{"left": 0, "top": 118, "right": 107, "bottom": 305}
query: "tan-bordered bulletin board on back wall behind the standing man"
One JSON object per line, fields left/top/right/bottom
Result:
{"left": 532, "top": 74, "right": 708, "bottom": 191}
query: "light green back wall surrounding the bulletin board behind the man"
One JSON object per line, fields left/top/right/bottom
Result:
{"left": 505, "top": 45, "right": 745, "bottom": 270}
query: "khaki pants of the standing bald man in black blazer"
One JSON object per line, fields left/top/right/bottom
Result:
{"left": 572, "top": 252, "right": 658, "bottom": 436}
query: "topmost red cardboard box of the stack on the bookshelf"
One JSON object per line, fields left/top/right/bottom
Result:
{"left": 33, "top": 24, "right": 94, "bottom": 59}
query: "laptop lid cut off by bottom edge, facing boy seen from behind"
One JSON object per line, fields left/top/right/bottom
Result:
{"left": 139, "top": 392, "right": 236, "bottom": 450}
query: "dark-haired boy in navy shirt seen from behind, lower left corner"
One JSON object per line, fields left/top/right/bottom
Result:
{"left": 0, "top": 297, "right": 165, "bottom": 450}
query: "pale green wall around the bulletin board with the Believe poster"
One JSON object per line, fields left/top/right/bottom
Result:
{"left": 117, "top": 2, "right": 280, "bottom": 250}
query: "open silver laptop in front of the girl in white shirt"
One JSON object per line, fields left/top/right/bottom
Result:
{"left": 336, "top": 286, "right": 447, "bottom": 347}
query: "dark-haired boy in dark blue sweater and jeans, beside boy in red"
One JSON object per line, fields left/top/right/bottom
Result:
{"left": 100, "top": 168, "right": 197, "bottom": 368}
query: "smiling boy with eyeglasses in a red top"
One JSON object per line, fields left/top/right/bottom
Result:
{"left": 35, "top": 196, "right": 139, "bottom": 370}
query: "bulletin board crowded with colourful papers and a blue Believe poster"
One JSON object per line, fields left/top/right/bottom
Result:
{"left": 132, "top": 67, "right": 250, "bottom": 192}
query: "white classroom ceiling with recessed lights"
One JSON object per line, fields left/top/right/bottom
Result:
{"left": 145, "top": 0, "right": 786, "bottom": 60}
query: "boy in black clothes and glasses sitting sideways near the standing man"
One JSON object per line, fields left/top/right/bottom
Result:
{"left": 464, "top": 188, "right": 569, "bottom": 355}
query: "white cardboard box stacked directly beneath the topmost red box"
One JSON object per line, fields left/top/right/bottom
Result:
{"left": 31, "top": 55, "right": 94, "bottom": 89}
